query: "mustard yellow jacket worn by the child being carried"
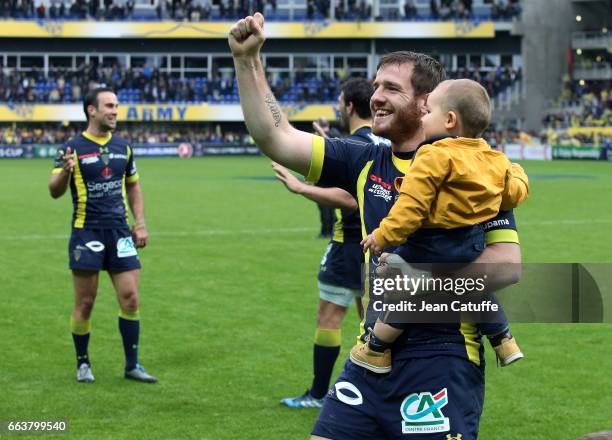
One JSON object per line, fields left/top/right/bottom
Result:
{"left": 374, "top": 137, "right": 529, "bottom": 248}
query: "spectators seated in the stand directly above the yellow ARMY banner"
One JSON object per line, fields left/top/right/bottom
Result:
{"left": 0, "top": 63, "right": 521, "bottom": 104}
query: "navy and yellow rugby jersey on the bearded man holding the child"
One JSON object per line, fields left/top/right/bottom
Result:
{"left": 306, "top": 136, "right": 518, "bottom": 365}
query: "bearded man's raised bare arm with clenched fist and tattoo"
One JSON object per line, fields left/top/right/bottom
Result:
{"left": 228, "top": 12, "right": 313, "bottom": 176}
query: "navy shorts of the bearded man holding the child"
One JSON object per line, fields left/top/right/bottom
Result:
{"left": 312, "top": 355, "right": 484, "bottom": 440}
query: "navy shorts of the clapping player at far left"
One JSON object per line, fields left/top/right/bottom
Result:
{"left": 68, "top": 226, "right": 140, "bottom": 272}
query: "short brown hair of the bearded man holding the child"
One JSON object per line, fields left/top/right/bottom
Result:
{"left": 376, "top": 50, "right": 446, "bottom": 96}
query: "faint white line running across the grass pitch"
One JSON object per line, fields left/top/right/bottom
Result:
{"left": 0, "top": 218, "right": 612, "bottom": 241}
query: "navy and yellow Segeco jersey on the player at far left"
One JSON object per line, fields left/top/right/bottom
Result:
{"left": 53, "top": 133, "right": 139, "bottom": 229}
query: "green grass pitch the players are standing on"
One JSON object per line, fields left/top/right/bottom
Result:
{"left": 0, "top": 157, "right": 612, "bottom": 440}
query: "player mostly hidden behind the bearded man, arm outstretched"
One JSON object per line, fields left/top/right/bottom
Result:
{"left": 272, "top": 78, "right": 386, "bottom": 408}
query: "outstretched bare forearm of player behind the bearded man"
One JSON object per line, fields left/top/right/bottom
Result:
{"left": 272, "top": 162, "right": 357, "bottom": 210}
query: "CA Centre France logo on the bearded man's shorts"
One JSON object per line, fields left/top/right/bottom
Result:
{"left": 400, "top": 388, "right": 450, "bottom": 434}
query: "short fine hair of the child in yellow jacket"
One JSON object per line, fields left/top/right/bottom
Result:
{"left": 442, "top": 79, "right": 491, "bottom": 138}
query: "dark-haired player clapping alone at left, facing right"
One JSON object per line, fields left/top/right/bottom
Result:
{"left": 49, "top": 87, "right": 157, "bottom": 383}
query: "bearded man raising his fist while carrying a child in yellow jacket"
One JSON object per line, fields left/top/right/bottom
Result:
{"left": 229, "top": 14, "right": 520, "bottom": 440}
